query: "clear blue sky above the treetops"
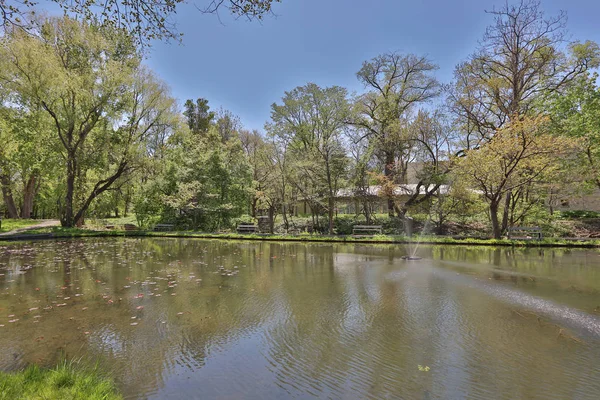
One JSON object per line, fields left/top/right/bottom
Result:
{"left": 146, "top": 0, "right": 600, "bottom": 130}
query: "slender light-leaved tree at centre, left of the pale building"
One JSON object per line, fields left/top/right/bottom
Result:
{"left": 271, "top": 83, "right": 350, "bottom": 234}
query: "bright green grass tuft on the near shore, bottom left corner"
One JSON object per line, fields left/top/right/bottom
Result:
{"left": 0, "top": 362, "right": 123, "bottom": 400}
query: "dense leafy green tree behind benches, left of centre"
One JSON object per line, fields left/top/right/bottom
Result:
{"left": 162, "top": 125, "right": 253, "bottom": 231}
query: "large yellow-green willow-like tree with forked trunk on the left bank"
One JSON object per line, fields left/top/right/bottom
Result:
{"left": 0, "top": 17, "right": 173, "bottom": 227}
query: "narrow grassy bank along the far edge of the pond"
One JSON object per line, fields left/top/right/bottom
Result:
{"left": 4, "top": 227, "right": 600, "bottom": 248}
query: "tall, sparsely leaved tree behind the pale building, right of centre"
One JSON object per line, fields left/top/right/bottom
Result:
{"left": 352, "top": 53, "right": 439, "bottom": 216}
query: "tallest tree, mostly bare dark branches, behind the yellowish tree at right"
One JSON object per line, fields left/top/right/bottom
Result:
{"left": 448, "top": 0, "right": 600, "bottom": 234}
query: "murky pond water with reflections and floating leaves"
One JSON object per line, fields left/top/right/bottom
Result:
{"left": 0, "top": 239, "right": 600, "bottom": 399}
